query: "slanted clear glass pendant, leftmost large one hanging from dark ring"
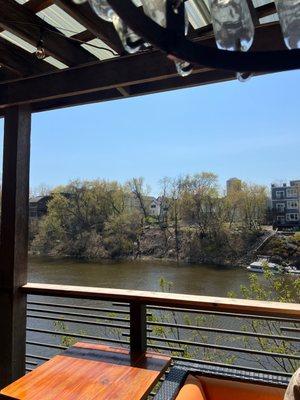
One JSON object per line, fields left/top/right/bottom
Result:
{"left": 89, "top": 0, "right": 144, "bottom": 53}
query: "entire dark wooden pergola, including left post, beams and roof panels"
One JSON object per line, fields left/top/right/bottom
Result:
{"left": 0, "top": 0, "right": 296, "bottom": 387}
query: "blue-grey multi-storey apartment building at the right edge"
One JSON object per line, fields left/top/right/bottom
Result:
{"left": 271, "top": 180, "right": 300, "bottom": 228}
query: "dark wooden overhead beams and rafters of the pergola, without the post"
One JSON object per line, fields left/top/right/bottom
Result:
{"left": 0, "top": 0, "right": 284, "bottom": 115}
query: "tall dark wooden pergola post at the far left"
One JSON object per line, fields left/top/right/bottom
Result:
{"left": 0, "top": 106, "right": 31, "bottom": 388}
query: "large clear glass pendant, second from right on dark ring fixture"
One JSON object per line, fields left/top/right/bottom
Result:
{"left": 209, "top": 0, "right": 254, "bottom": 51}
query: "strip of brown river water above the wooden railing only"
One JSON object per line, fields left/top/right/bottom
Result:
{"left": 28, "top": 258, "right": 249, "bottom": 297}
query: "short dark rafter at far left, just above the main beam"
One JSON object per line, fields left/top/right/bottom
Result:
{"left": 0, "top": 37, "right": 56, "bottom": 76}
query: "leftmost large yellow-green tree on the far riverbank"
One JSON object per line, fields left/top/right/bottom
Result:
{"left": 33, "top": 181, "right": 126, "bottom": 257}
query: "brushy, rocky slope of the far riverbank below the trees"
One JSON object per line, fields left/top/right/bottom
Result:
{"left": 30, "top": 226, "right": 290, "bottom": 266}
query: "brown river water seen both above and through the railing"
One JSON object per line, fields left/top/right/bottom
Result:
{"left": 27, "top": 258, "right": 298, "bottom": 369}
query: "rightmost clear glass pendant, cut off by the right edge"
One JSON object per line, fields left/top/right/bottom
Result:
{"left": 275, "top": 0, "right": 300, "bottom": 49}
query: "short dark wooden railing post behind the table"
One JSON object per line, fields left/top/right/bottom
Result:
{"left": 130, "top": 302, "right": 147, "bottom": 357}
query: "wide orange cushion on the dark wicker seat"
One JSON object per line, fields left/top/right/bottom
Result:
{"left": 196, "top": 376, "right": 285, "bottom": 400}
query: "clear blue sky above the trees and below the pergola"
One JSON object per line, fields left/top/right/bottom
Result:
{"left": 0, "top": 71, "right": 300, "bottom": 194}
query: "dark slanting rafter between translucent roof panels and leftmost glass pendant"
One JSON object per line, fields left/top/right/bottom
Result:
{"left": 54, "top": 0, "right": 124, "bottom": 54}
